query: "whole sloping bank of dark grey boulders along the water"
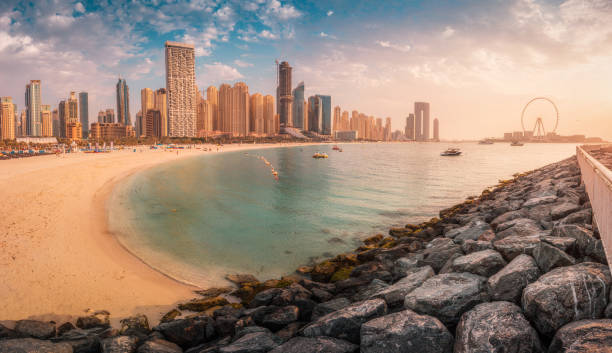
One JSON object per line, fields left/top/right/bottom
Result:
{"left": 0, "top": 158, "right": 612, "bottom": 353}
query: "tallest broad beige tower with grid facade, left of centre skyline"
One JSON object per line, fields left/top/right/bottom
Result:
{"left": 165, "top": 42, "right": 197, "bottom": 137}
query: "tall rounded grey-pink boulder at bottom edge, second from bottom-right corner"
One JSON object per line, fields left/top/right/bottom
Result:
{"left": 455, "top": 302, "right": 543, "bottom": 353}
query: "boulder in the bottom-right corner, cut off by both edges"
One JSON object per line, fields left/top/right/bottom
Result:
{"left": 548, "top": 319, "right": 612, "bottom": 353}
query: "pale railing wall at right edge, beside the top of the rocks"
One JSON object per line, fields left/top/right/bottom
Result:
{"left": 576, "top": 145, "right": 612, "bottom": 268}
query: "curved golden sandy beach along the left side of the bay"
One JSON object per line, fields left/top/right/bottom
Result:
{"left": 0, "top": 140, "right": 322, "bottom": 322}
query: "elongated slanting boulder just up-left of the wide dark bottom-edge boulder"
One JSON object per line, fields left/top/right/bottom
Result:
{"left": 302, "top": 299, "right": 387, "bottom": 343}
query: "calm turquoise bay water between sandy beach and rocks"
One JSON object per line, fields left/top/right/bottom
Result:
{"left": 108, "top": 143, "right": 575, "bottom": 286}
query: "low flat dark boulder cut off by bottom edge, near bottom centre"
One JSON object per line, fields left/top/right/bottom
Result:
{"left": 270, "top": 337, "right": 359, "bottom": 353}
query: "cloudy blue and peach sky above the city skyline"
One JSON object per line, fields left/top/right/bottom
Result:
{"left": 0, "top": 0, "right": 612, "bottom": 140}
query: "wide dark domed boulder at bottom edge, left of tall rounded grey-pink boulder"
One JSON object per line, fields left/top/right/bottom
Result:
{"left": 361, "top": 310, "right": 453, "bottom": 353}
